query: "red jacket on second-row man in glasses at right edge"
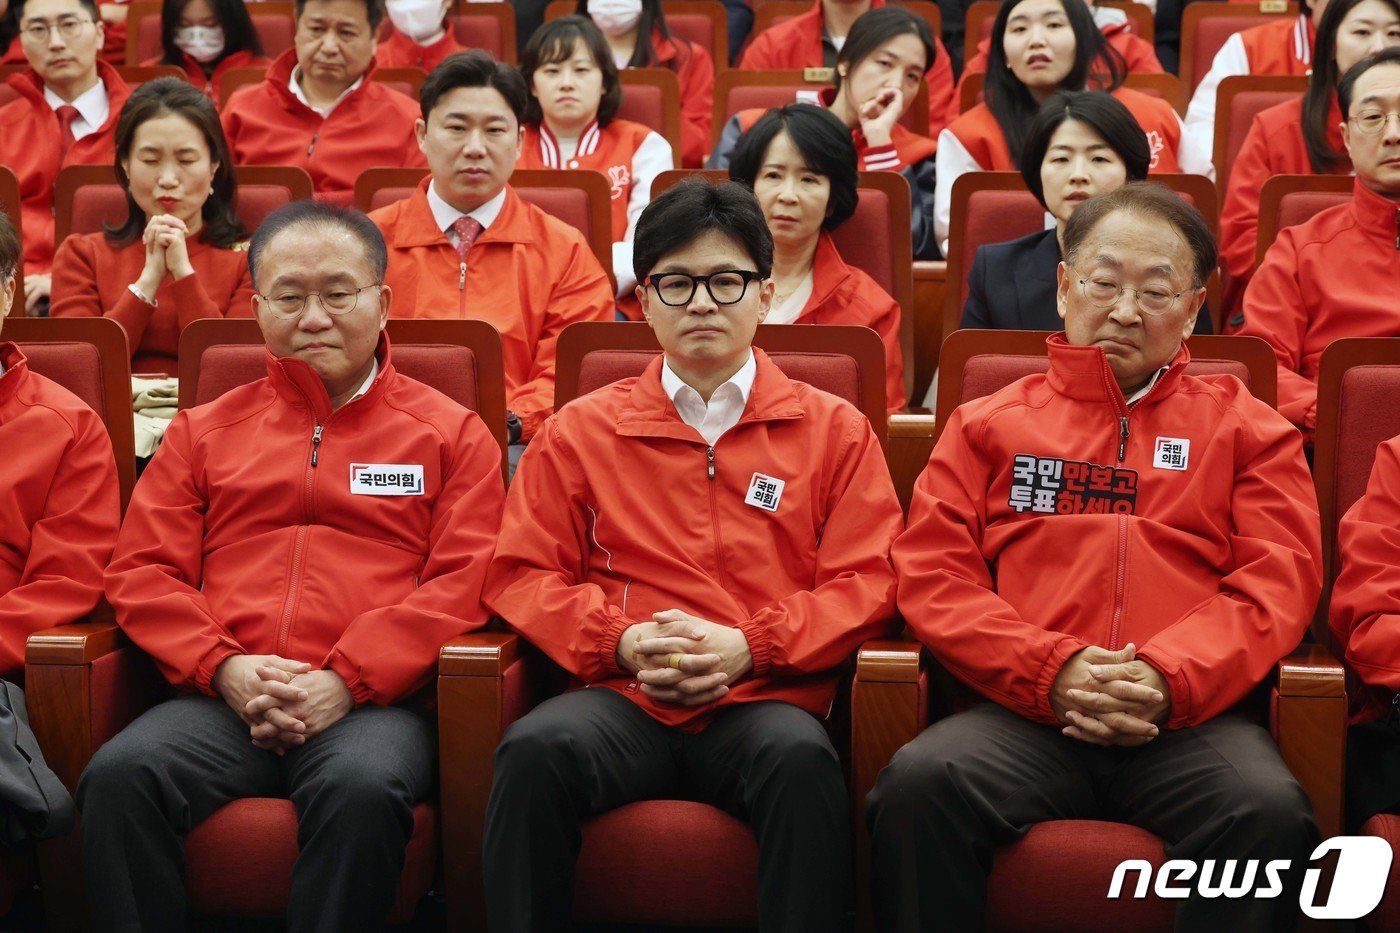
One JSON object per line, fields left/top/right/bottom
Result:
{"left": 1240, "top": 178, "right": 1400, "bottom": 436}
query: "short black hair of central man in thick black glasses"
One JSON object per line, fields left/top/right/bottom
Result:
{"left": 631, "top": 178, "right": 773, "bottom": 282}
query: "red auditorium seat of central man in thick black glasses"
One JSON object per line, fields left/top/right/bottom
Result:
{"left": 438, "top": 322, "right": 885, "bottom": 927}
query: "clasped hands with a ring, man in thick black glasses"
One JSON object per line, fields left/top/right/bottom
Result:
{"left": 617, "top": 609, "right": 753, "bottom": 707}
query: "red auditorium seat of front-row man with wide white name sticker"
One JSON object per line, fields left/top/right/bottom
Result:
{"left": 25, "top": 318, "right": 505, "bottom": 929}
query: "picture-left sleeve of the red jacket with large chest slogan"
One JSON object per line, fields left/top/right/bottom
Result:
{"left": 895, "top": 409, "right": 1089, "bottom": 724}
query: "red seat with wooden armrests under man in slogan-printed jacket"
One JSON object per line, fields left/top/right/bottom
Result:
{"left": 851, "top": 331, "right": 1345, "bottom": 930}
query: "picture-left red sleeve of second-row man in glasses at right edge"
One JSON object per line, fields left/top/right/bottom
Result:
{"left": 1240, "top": 227, "right": 1317, "bottom": 428}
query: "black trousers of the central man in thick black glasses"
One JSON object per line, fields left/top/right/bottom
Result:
{"left": 483, "top": 689, "right": 851, "bottom": 933}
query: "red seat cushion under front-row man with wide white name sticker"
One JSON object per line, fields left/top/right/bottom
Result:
{"left": 185, "top": 797, "right": 437, "bottom": 923}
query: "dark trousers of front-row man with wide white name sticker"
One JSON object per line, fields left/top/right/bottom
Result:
{"left": 78, "top": 696, "right": 437, "bottom": 930}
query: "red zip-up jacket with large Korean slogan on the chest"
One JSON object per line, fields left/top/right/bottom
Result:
{"left": 895, "top": 333, "right": 1322, "bottom": 728}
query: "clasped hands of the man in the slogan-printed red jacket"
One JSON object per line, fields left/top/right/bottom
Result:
{"left": 1050, "top": 644, "right": 1172, "bottom": 747}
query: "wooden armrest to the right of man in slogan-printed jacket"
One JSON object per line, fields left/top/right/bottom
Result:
{"left": 1274, "top": 644, "right": 1347, "bottom": 839}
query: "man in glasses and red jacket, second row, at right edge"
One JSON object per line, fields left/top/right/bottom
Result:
{"left": 1240, "top": 48, "right": 1400, "bottom": 437}
